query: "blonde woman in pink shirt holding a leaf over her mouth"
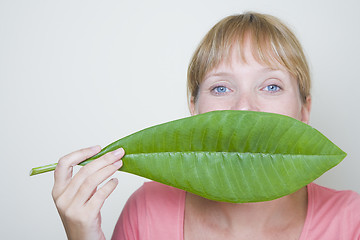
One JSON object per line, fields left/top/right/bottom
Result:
{"left": 53, "top": 13, "right": 360, "bottom": 240}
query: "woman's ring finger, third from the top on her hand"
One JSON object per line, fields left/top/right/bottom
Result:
{"left": 73, "top": 160, "right": 122, "bottom": 206}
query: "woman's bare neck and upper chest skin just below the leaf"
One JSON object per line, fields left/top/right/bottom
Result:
{"left": 187, "top": 187, "right": 307, "bottom": 231}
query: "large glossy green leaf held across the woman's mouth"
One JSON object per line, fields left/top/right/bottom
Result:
{"left": 30, "top": 110, "right": 346, "bottom": 203}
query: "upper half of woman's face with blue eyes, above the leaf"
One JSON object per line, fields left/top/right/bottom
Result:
{"left": 191, "top": 45, "right": 311, "bottom": 123}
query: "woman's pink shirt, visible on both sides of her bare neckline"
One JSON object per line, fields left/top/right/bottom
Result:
{"left": 112, "top": 182, "right": 360, "bottom": 240}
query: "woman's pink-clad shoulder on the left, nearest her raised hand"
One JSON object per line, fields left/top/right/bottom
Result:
{"left": 113, "top": 182, "right": 186, "bottom": 239}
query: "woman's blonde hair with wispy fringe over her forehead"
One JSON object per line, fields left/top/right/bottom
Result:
{"left": 187, "top": 12, "right": 311, "bottom": 103}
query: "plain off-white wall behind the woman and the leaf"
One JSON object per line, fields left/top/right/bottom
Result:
{"left": 0, "top": 0, "right": 360, "bottom": 239}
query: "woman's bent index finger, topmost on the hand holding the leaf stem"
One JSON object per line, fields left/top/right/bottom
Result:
{"left": 53, "top": 146, "right": 101, "bottom": 198}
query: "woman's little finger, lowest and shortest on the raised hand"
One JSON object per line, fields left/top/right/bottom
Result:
{"left": 86, "top": 178, "right": 118, "bottom": 213}
